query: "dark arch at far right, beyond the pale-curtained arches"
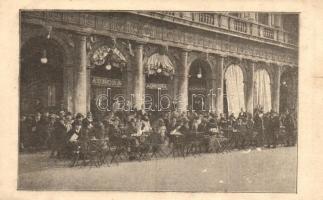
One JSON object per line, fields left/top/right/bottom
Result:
{"left": 279, "top": 69, "right": 298, "bottom": 112}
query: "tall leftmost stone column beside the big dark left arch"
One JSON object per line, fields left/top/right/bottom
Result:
{"left": 74, "top": 35, "right": 87, "bottom": 114}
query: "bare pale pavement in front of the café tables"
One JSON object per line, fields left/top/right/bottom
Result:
{"left": 18, "top": 147, "right": 297, "bottom": 193}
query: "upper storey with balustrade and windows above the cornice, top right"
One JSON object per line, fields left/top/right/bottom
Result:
{"left": 135, "top": 11, "right": 298, "bottom": 49}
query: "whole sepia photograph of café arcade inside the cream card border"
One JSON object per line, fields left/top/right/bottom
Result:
{"left": 17, "top": 9, "right": 300, "bottom": 194}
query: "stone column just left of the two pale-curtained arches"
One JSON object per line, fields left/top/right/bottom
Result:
{"left": 216, "top": 56, "right": 224, "bottom": 114}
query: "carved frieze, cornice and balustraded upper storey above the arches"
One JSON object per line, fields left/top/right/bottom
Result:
{"left": 21, "top": 10, "right": 298, "bottom": 66}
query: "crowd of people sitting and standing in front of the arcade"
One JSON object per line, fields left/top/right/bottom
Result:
{"left": 19, "top": 105, "right": 297, "bottom": 158}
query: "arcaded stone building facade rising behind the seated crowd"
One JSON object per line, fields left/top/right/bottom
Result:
{"left": 20, "top": 11, "right": 298, "bottom": 119}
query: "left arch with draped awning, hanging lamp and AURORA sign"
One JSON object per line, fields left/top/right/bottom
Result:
{"left": 90, "top": 44, "right": 127, "bottom": 120}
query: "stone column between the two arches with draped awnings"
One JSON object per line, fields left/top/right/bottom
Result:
{"left": 133, "top": 44, "right": 145, "bottom": 109}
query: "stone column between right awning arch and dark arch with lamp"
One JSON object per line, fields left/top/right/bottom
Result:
{"left": 178, "top": 50, "right": 189, "bottom": 111}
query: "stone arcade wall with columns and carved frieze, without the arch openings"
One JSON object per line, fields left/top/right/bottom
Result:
{"left": 21, "top": 12, "right": 297, "bottom": 113}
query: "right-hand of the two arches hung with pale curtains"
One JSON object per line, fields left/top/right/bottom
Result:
{"left": 253, "top": 68, "right": 272, "bottom": 113}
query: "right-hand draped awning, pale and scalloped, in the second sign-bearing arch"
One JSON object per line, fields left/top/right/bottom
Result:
{"left": 145, "top": 53, "right": 175, "bottom": 76}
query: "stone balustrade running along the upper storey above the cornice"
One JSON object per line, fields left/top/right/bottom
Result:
{"left": 137, "top": 11, "right": 297, "bottom": 46}
